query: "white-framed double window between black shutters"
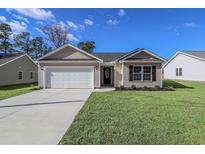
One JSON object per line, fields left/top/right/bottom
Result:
{"left": 133, "top": 66, "right": 152, "bottom": 81}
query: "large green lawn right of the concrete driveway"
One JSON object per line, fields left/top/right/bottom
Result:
{"left": 60, "top": 81, "right": 205, "bottom": 144}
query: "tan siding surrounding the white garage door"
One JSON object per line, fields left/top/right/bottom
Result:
{"left": 39, "top": 62, "right": 100, "bottom": 88}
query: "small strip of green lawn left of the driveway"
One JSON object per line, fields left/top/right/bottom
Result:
{"left": 0, "top": 83, "right": 37, "bottom": 100}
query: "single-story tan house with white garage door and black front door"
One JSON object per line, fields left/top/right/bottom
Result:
{"left": 38, "top": 44, "right": 165, "bottom": 88}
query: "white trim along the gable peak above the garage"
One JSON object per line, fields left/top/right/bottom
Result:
{"left": 38, "top": 44, "right": 103, "bottom": 62}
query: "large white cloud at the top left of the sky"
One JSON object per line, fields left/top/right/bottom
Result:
{"left": 7, "top": 8, "right": 55, "bottom": 20}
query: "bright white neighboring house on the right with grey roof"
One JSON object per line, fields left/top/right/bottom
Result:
{"left": 163, "top": 51, "right": 205, "bottom": 81}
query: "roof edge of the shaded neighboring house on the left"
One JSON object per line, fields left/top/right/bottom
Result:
{"left": 0, "top": 53, "right": 37, "bottom": 67}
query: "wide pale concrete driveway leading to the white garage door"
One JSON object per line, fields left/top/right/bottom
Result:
{"left": 0, "top": 89, "right": 92, "bottom": 144}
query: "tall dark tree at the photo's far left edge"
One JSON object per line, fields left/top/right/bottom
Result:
{"left": 0, "top": 23, "right": 12, "bottom": 56}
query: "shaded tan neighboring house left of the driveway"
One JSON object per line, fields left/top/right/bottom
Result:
{"left": 0, "top": 53, "right": 38, "bottom": 86}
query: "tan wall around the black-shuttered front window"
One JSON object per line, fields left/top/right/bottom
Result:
{"left": 123, "top": 63, "right": 162, "bottom": 88}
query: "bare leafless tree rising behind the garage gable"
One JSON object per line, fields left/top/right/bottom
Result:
{"left": 40, "top": 24, "right": 69, "bottom": 48}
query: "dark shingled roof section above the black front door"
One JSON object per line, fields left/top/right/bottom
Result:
{"left": 93, "top": 52, "right": 127, "bottom": 62}
